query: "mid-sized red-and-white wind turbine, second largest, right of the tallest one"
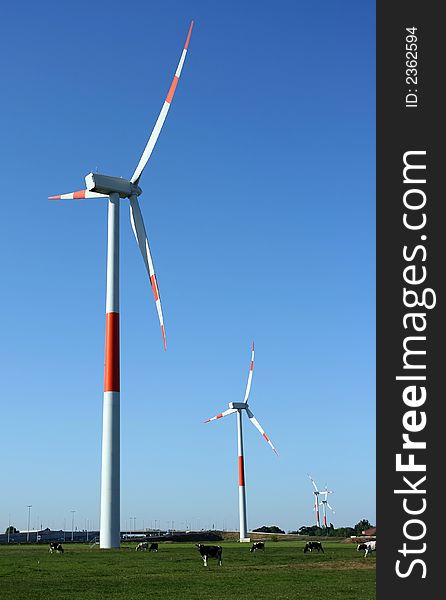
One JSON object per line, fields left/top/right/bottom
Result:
{"left": 205, "top": 342, "right": 278, "bottom": 542}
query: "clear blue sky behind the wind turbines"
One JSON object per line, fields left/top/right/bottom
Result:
{"left": 0, "top": 0, "right": 376, "bottom": 531}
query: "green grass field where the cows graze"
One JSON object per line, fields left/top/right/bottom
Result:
{"left": 0, "top": 542, "right": 376, "bottom": 600}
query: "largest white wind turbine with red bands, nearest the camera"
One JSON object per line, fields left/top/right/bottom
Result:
{"left": 49, "top": 21, "right": 193, "bottom": 548}
